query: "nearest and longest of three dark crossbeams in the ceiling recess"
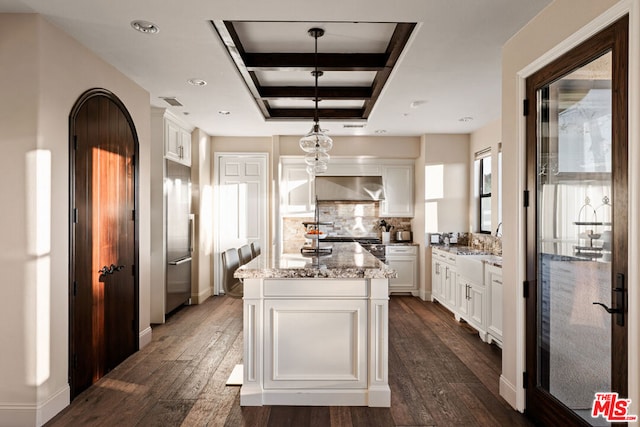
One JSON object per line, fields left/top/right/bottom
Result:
{"left": 242, "top": 52, "right": 388, "bottom": 71}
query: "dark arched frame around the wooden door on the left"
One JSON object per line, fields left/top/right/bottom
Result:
{"left": 68, "top": 88, "right": 140, "bottom": 400}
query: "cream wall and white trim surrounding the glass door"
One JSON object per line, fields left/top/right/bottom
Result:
{"left": 500, "top": 0, "right": 640, "bottom": 413}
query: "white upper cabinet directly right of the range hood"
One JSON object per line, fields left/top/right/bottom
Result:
{"left": 380, "top": 165, "right": 414, "bottom": 218}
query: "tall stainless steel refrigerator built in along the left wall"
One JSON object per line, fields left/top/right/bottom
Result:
{"left": 165, "top": 160, "right": 193, "bottom": 313}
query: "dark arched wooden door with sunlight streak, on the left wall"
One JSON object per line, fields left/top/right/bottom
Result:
{"left": 69, "top": 90, "right": 138, "bottom": 397}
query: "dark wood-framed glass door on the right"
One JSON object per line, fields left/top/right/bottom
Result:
{"left": 527, "top": 19, "right": 627, "bottom": 425}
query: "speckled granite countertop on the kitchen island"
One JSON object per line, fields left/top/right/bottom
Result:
{"left": 234, "top": 242, "right": 397, "bottom": 279}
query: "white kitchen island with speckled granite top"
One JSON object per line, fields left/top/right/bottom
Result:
{"left": 235, "top": 243, "right": 395, "bottom": 407}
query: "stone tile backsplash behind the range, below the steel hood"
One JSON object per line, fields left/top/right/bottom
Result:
{"left": 283, "top": 202, "right": 411, "bottom": 250}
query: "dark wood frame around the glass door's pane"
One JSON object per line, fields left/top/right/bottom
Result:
{"left": 524, "top": 16, "right": 629, "bottom": 426}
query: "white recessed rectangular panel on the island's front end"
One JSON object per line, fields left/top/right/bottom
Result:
{"left": 264, "top": 298, "right": 368, "bottom": 390}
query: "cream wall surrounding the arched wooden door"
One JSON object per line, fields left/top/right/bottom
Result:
{"left": 0, "top": 14, "right": 150, "bottom": 426}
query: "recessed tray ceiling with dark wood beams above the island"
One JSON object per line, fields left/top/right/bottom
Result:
{"left": 212, "top": 21, "right": 416, "bottom": 121}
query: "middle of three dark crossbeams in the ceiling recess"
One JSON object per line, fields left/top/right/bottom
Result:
{"left": 258, "top": 86, "right": 372, "bottom": 100}
